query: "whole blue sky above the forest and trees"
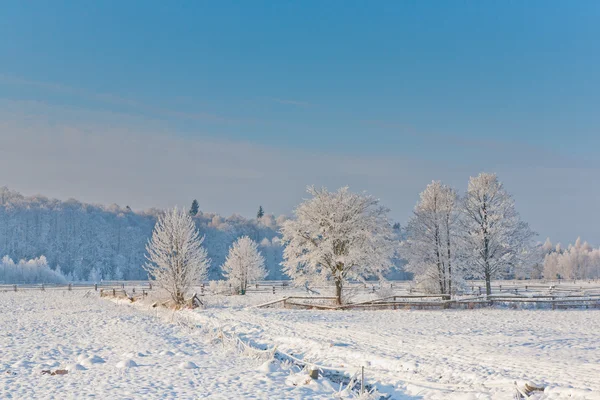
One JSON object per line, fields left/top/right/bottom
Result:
{"left": 0, "top": 0, "right": 600, "bottom": 243}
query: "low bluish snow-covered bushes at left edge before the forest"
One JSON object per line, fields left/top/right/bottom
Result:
{"left": 0, "top": 256, "right": 67, "bottom": 283}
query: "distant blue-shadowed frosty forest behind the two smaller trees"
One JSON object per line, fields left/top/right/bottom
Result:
{"left": 0, "top": 187, "right": 285, "bottom": 280}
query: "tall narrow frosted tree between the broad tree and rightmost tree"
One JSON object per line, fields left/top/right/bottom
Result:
{"left": 401, "top": 181, "right": 460, "bottom": 294}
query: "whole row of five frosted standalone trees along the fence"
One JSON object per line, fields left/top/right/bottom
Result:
{"left": 147, "top": 173, "right": 541, "bottom": 303}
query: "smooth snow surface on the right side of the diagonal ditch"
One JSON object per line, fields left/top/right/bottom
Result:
{"left": 196, "top": 302, "right": 600, "bottom": 399}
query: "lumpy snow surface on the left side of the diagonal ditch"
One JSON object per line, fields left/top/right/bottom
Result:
{"left": 0, "top": 291, "right": 335, "bottom": 399}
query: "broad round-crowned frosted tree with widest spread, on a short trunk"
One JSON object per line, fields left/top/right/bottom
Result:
{"left": 281, "top": 187, "right": 395, "bottom": 304}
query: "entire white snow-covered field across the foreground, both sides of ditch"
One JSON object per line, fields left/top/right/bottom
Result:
{"left": 0, "top": 291, "right": 600, "bottom": 399}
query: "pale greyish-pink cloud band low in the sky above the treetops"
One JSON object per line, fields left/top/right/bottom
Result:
{"left": 0, "top": 100, "right": 600, "bottom": 241}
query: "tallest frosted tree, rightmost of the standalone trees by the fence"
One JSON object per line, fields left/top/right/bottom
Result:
{"left": 461, "top": 173, "right": 535, "bottom": 295}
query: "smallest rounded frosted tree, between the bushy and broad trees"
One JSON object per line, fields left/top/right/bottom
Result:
{"left": 222, "top": 236, "right": 267, "bottom": 294}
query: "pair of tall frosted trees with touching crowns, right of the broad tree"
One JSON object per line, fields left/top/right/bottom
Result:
{"left": 400, "top": 173, "right": 540, "bottom": 294}
